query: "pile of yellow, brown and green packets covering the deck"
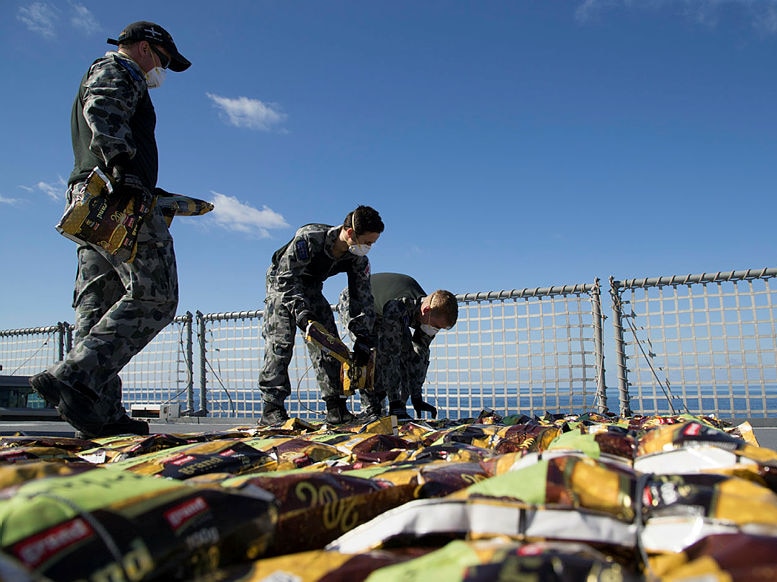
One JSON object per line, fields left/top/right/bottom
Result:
{"left": 0, "top": 411, "right": 777, "bottom": 582}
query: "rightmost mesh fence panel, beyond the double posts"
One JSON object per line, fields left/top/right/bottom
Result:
{"left": 611, "top": 269, "right": 777, "bottom": 418}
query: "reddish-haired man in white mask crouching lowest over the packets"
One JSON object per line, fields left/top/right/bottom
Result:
{"left": 337, "top": 273, "right": 459, "bottom": 421}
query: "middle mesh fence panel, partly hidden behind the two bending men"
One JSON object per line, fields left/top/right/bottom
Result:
{"left": 198, "top": 285, "right": 604, "bottom": 418}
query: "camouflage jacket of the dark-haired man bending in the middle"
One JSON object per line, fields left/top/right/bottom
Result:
{"left": 267, "top": 224, "right": 375, "bottom": 337}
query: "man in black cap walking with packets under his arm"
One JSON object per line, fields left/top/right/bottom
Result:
{"left": 30, "top": 21, "right": 191, "bottom": 438}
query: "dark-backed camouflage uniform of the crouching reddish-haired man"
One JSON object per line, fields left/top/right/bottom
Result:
{"left": 337, "top": 273, "right": 434, "bottom": 402}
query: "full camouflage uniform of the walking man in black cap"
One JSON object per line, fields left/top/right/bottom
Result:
{"left": 49, "top": 52, "right": 178, "bottom": 422}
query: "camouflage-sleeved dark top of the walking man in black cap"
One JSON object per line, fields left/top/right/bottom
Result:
{"left": 68, "top": 51, "right": 159, "bottom": 189}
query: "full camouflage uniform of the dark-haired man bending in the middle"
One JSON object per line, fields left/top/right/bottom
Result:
{"left": 259, "top": 224, "right": 375, "bottom": 405}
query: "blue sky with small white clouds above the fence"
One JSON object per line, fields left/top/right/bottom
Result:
{"left": 0, "top": 0, "right": 777, "bottom": 329}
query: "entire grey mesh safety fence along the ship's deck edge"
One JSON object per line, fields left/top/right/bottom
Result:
{"left": 0, "top": 269, "right": 777, "bottom": 419}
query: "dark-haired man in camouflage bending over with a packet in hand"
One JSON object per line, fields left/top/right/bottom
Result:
{"left": 259, "top": 206, "right": 384, "bottom": 425}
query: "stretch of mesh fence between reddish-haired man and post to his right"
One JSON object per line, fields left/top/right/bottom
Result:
{"left": 434, "top": 284, "right": 606, "bottom": 418}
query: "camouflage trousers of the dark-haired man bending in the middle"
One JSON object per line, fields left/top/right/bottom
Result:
{"left": 259, "top": 273, "right": 342, "bottom": 404}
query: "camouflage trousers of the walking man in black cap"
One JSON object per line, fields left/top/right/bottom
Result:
{"left": 49, "top": 187, "right": 178, "bottom": 422}
